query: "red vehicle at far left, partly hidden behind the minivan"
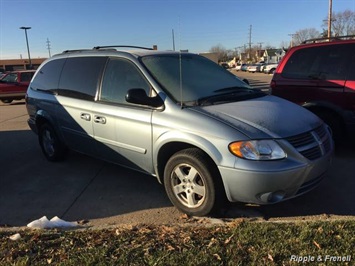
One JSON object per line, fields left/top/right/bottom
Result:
{"left": 0, "top": 70, "right": 35, "bottom": 103}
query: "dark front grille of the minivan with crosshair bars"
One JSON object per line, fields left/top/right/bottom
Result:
{"left": 286, "top": 125, "right": 332, "bottom": 160}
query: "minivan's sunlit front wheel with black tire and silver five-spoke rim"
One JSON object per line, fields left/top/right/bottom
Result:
{"left": 164, "top": 148, "right": 226, "bottom": 216}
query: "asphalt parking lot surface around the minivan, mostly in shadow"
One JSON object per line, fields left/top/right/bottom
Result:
{"left": 0, "top": 72, "right": 355, "bottom": 227}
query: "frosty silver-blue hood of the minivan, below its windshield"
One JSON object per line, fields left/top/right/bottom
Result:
{"left": 198, "top": 95, "right": 322, "bottom": 139}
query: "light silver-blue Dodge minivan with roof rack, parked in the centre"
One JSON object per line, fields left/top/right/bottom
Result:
{"left": 26, "top": 47, "right": 333, "bottom": 216}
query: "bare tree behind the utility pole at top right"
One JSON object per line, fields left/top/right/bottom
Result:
{"left": 322, "top": 10, "right": 355, "bottom": 37}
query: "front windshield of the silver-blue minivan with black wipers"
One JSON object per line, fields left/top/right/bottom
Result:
{"left": 141, "top": 53, "right": 264, "bottom": 105}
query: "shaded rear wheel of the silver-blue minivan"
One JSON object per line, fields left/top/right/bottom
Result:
{"left": 38, "top": 124, "right": 67, "bottom": 162}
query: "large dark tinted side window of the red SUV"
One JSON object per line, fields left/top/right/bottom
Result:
{"left": 282, "top": 44, "right": 352, "bottom": 80}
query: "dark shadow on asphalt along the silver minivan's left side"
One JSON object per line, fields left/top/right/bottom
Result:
{"left": 0, "top": 130, "right": 172, "bottom": 226}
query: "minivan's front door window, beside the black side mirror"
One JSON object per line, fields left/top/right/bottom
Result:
{"left": 100, "top": 59, "right": 150, "bottom": 104}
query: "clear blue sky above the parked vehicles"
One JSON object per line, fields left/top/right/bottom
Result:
{"left": 0, "top": 0, "right": 355, "bottom": 59}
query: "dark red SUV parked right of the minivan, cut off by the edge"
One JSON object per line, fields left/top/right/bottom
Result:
{"left": 271, "top": 36, "right": 355, "bottom": 139}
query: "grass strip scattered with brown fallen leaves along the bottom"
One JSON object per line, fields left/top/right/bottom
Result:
{"left": 0, "top": 220, "right": 355, "bottom": 266}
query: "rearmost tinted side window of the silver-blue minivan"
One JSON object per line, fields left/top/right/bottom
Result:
{"left": 31, "top": 59, "right": 65, "bottom": 91}
